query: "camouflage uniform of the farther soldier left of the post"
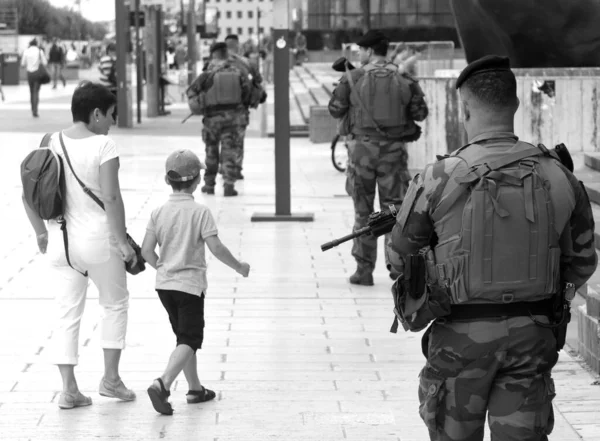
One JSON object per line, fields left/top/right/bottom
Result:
{"left": 191, "top": 60, "right": 250, "bottom": 187}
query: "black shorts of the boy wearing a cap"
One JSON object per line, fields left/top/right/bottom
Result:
{"left": 156, "top": 289, "right": 204, "bottom": 352}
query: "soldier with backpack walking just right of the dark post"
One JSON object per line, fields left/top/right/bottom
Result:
{"left": 329, "top": 31, "right": 428, "bottom": 286}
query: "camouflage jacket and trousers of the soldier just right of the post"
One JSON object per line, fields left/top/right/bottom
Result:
{"left": 329, "top": 60, "right": 428, "bottom": 274}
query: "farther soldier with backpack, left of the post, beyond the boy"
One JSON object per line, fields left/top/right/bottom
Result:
{"left": 190, "top": 43, "right": 251, "bottom": 196}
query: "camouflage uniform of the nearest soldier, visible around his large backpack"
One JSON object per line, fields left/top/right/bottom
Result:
{"left": 389, "top": 133, "right": 597, "bottom": 441}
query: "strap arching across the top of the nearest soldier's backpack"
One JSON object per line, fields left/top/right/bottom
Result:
{"left": 436, "top": 141, "right": 556, "bottom": 216}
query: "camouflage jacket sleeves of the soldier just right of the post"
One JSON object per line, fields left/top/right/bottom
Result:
{"left": 329, "top": 60, "right": 429, "bottom": 132}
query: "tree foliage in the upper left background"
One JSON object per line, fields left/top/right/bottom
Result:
{"left": 17, "top": 0, "right": 106, "bottom": 40}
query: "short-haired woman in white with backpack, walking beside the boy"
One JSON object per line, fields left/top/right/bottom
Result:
{"left": 21, "top": 83, "right": 143, "bottom": 409}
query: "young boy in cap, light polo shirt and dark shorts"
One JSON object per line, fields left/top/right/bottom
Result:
{"left": 142, "top": 150, "right": 250, "bottom": 415}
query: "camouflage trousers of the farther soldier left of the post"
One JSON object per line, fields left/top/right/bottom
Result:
{"left": 202, "top": 112, "right": 248, "bottom": 187}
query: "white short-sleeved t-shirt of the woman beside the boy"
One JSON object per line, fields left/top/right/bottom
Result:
{"left": 50, "top": 134, "right": 119, "bottom": 263}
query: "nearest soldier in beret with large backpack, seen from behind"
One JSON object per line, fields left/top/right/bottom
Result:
{"left": 390, "top": 56, "right": 597, "bottom": 441}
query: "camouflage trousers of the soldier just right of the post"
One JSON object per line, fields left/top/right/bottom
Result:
{"left": 346, "top": 137, "right": 410, "bottom": 272}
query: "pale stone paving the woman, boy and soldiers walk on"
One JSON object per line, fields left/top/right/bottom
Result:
{"left": 0, "top": 131, "right": 600, "bottom": 441}
